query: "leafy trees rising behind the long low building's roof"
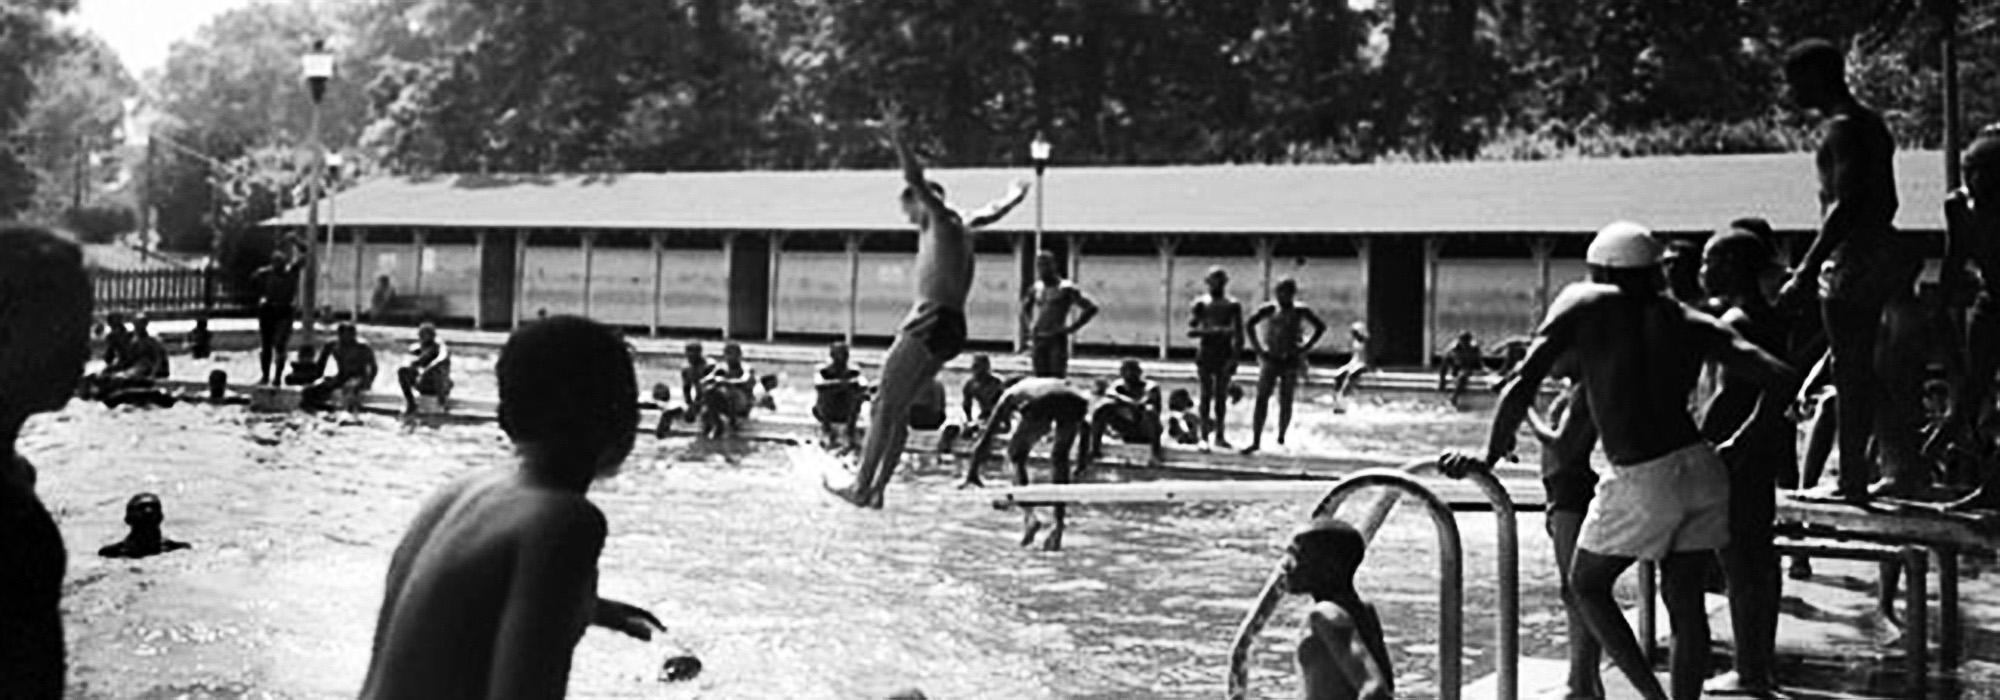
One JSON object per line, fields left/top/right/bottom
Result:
{"left": 0, "top": 0, "right": 2000, "bottom": 248}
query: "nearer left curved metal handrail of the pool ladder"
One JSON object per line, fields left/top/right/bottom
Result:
{"left": 1228, "top": 460, "right": 1464, "bottom": 700}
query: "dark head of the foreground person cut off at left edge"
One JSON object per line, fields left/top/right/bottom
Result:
{"left": 0, "top": 224, "right": 90, "bottom": 438}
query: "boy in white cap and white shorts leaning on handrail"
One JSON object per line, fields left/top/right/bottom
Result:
{"left": 1442, "top": 222, "right": 1796, "bottom": 700}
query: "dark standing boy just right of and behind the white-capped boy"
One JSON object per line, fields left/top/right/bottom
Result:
{"left": 1700, "top": 230, "right": 1798, "bottom": 696}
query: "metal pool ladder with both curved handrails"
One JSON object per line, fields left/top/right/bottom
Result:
{"left": 1228, "top": 460, "right": 1520, "bottom": 700}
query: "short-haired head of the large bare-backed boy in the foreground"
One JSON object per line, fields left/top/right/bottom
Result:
{"left": 494, "top": 316, "right": 638, "bottom": 484}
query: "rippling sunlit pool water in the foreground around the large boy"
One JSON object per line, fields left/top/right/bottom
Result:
{"left": 22, "top": 402, "right": 1562, "bottom": 698}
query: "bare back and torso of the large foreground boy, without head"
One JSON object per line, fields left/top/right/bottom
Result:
{"left": 362, "top": 470, "right": 606, "bottom": 698}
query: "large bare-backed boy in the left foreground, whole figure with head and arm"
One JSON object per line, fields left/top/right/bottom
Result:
{"left": 360, "top": 316, "right": 666, "bottom": 698}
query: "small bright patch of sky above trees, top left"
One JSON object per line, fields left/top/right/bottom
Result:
{"left": 60, "top": 0, "right": 252, "bottom": 78}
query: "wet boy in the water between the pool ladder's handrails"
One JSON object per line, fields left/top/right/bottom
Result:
{"left": 1284, "top": 516, "right": 1396, "bottom": 700}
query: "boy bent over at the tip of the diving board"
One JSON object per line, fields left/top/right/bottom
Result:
{"left": 958, "top": 376, "right": 1090, "bottom": 552}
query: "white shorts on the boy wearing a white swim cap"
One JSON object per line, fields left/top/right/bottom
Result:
{"left": 1576, "top": 442, "right": 1730, "bottom": 560}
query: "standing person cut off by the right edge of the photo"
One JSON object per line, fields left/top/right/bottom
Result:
{"left": 1924, "top": 124, "right": 2000, "bottom": 508}
